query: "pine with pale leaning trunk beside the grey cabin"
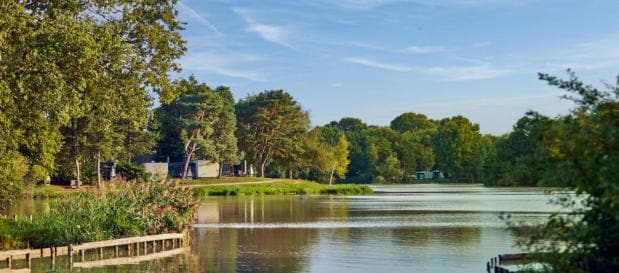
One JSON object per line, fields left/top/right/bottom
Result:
{"left": 156, "top": 76, "right": 239, "bottom": 178}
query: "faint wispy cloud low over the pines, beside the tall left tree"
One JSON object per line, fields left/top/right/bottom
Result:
{"left": 181, "top": 53, "right": 268, "bottom": 82}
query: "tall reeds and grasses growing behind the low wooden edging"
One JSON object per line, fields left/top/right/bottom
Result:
{"left": 0, "top": 182, "right": 197, "bottom": 248}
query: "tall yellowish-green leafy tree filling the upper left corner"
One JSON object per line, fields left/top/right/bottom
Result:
{"left": 0, "top": 0, "right": 185, "bottom": 188}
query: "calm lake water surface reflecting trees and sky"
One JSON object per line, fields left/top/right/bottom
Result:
{"left": 9, "top": 184, "right": 557, "bottom": 273}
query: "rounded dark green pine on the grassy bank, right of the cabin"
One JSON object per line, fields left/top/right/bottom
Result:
{"left": 236, "top": 90, "right": 309, "bottom": 177}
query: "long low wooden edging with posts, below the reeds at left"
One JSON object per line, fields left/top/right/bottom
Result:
{"left": 0, "top": 233, "right": 185, "bottom": 268}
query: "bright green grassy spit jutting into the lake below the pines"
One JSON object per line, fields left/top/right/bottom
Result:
{"left": 192, "top": 179, "right": 373, "bottom": 197}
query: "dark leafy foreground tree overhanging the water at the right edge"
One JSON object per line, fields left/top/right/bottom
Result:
{"left": 526, "top": 70, "right": 619, "bottom": 273}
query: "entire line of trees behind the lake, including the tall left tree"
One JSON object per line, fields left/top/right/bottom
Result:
{"left": 0, "top": 0, "right": 600, "bottom": 205}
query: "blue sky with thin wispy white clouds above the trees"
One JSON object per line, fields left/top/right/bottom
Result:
{"left": 177, "top": 0, "right": 619, "bottom": 134}
